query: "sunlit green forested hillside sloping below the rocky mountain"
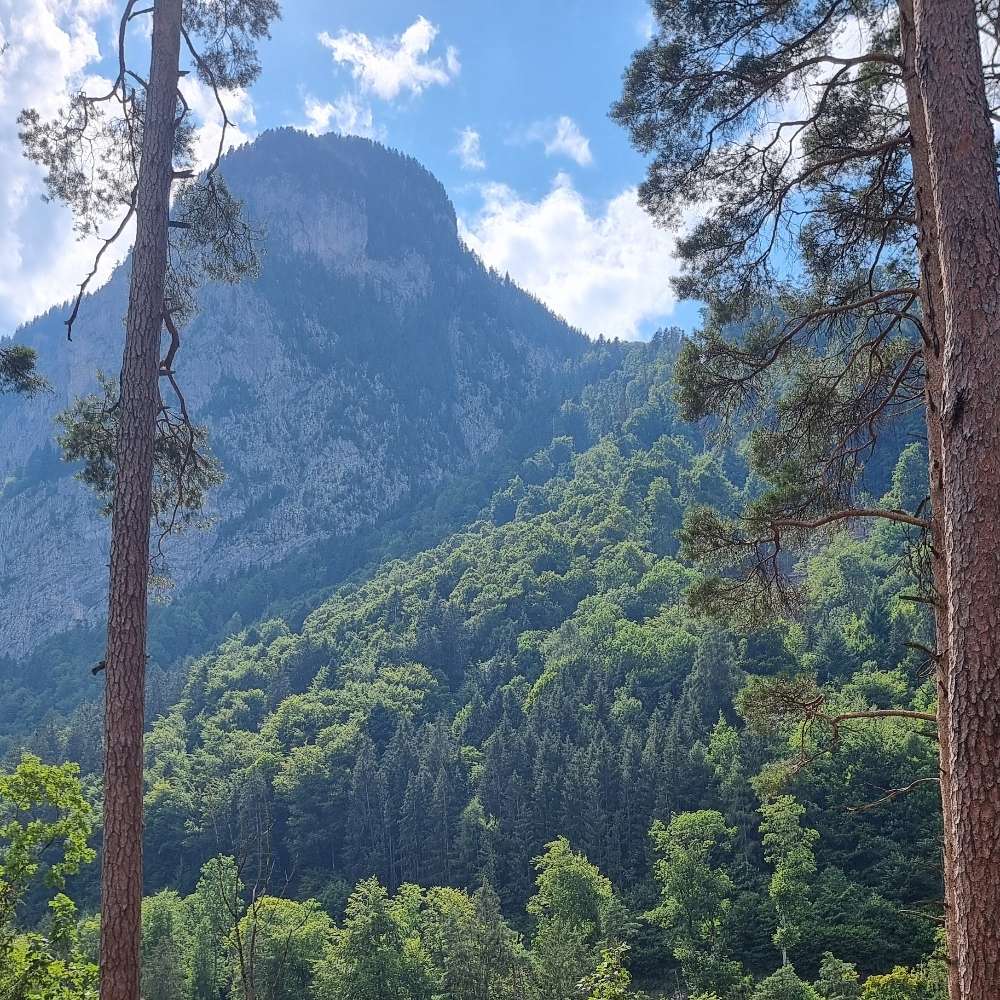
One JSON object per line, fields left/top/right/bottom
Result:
{"left": 19, "top": 335, "right": 942, "bottom": 997}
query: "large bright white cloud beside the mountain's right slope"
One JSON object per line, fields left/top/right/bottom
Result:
{"left": 460, "top": 174, "right": 678, "bottom": 340}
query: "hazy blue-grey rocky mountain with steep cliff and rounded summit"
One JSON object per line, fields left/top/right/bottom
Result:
{"left": 0, "top": 130, "right": 585, "bottom": 657}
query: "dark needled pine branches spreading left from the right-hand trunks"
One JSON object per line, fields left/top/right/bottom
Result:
{"left": 612, "top": 0, "right": 933, "bottom": 680}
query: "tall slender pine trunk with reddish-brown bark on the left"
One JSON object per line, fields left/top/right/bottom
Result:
{"left": 100, "top": 0, "right": 182, "bottom": 1000}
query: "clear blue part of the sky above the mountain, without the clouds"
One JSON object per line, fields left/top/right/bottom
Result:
{"left": 255, "top": 0, "right": 648, "bottom": 209}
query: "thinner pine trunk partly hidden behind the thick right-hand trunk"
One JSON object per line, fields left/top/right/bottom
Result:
{"left": 899, "top": 0, "right": 961, "bottom": 1000}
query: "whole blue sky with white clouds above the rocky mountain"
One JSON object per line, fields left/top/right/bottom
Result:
{"left": 0, "top": 0, "right": 694, "bottom": 338}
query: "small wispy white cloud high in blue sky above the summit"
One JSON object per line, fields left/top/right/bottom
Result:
{"left": 319, "top": 17, "right": 462, "bottom": 101}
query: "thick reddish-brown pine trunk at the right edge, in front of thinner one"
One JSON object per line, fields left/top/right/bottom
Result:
{"left": 914, "top": 0, "right": 1000, "bottom": 988}
